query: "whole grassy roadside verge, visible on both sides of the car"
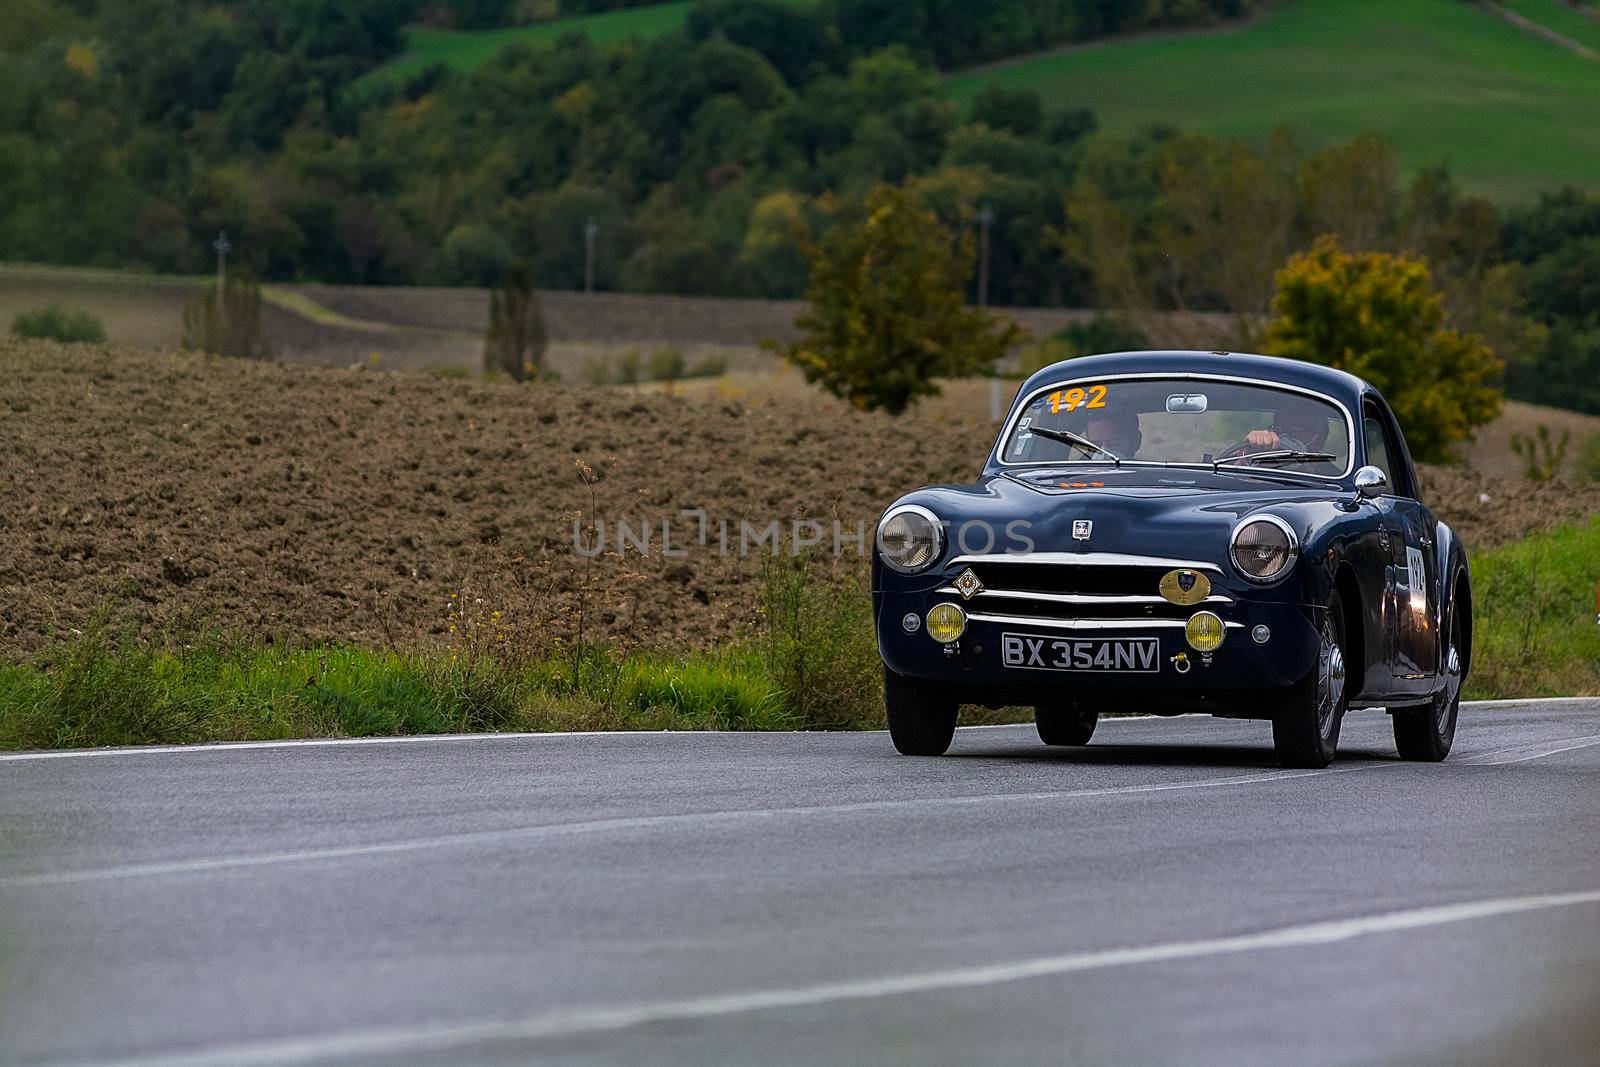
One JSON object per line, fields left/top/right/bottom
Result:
{"left": 0, "top": 518, "right": 1600, "bottom": 749}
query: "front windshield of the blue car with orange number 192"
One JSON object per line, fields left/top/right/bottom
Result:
{"left": 1000, "top": 378, "right": 1350, "bottom": 477}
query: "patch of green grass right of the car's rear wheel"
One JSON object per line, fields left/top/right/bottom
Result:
{"left": 1467, "top": 518, "right": 1600, "bottom": 699}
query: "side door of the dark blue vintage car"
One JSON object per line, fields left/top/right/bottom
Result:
{"left": 1362, "top": 400, "right": 1438, "bottom": 694}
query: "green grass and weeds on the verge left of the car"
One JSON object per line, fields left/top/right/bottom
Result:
{"left": 0, "top": 560, "right": 883, "bottom": 749}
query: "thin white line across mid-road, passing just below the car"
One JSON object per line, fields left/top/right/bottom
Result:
{"left": 0, "top": 763, "right": 1376, "bottom": 889}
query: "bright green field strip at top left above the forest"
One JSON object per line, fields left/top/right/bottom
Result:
{"left": 363, "top": 0, "right": 694, "bottom": 82}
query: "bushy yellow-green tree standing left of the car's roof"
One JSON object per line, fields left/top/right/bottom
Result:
{"left": 782, "top": 186, "right": 1026, "bottom": 414}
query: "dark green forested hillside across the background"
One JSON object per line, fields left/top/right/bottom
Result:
{"left": 0, "top": 0, "right": 1600, "bottom": 411}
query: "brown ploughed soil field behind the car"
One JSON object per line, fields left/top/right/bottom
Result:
{"left": 0, "top": 339, "right": 1600, "bottom": 654}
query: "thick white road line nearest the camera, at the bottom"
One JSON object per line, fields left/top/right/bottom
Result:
{"left": 81, "top": 889, "right": 1600, "bottom": 1067}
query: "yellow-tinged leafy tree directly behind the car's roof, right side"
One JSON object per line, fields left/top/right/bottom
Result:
{"left": 1266, "top": 234, "right": 1502, "bottom": 462}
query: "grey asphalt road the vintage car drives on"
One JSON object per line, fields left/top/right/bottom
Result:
{"left": 0, "top": 701, "right": 1600, "bottom": 1064}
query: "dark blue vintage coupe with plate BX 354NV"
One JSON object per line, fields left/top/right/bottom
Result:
{"left": 872, "top": 352, "right": 1472, "bottom": 766}
